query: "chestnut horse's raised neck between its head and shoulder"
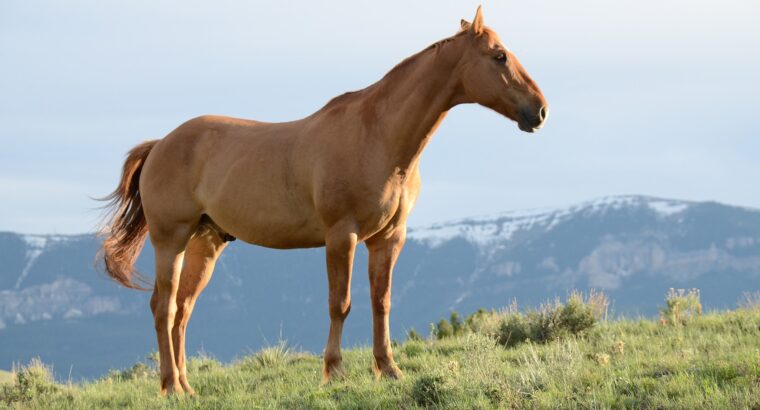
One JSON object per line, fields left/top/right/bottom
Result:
{"left": 364, "top": 47, "right": 460, "bottom": 172}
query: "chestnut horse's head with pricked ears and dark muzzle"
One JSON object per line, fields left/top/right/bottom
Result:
{"left": 458, "top": 7, "right": 549, "bottom": 132}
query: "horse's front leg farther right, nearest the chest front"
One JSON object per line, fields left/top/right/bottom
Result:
{"left": 366, "top": 225, "right": 406, "bottom": 379}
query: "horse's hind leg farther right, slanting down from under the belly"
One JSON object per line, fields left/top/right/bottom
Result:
{"left": 172, "top": 230, "right": 227, "bottom": 394}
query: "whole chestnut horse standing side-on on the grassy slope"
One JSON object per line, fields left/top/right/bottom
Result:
{"left": 101, "top": 7, "right": 548, "bottom": 394}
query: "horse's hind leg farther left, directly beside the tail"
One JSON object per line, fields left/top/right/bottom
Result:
{"left": 149, "top": 223, "right": 195, "bottom": 394}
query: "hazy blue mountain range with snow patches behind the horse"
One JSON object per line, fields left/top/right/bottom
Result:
{"left": 0, "top": 196, "right": 760, "bottom": 379}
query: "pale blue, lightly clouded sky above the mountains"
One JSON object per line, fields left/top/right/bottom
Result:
{"left": 0, "top": 0, "right": 760, "bottom": 233}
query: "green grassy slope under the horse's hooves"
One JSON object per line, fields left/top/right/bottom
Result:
{"left": 0, "top": 309, "right": 760, "bottom": 409}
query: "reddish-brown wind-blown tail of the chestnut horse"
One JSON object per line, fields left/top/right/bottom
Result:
{"left": 98, "top": 140, "right": 158, "bottom": 290}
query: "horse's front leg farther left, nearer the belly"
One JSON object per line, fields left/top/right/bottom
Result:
{"left": 323, "top": 223, "right": 357, "bottom": 383}
